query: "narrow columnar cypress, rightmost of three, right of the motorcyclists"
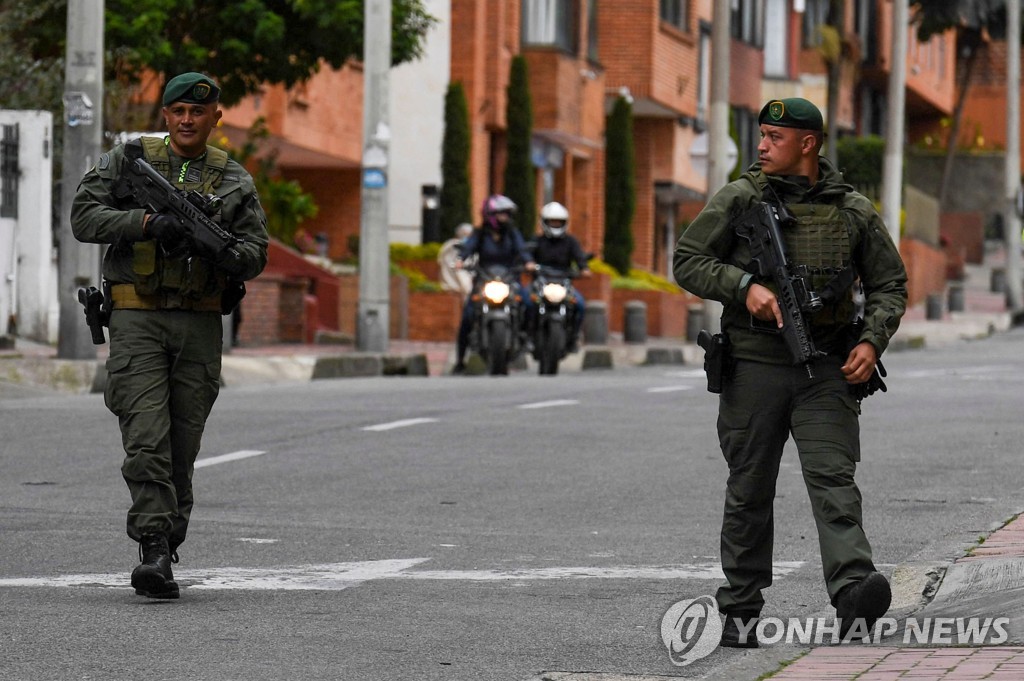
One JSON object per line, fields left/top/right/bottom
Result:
{"left": 604, "top": 97, "right": 636, "bottom": 276}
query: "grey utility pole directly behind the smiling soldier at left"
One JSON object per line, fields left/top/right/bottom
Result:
{"left": 57, "top": 0, "right": 103, "bottom": 359}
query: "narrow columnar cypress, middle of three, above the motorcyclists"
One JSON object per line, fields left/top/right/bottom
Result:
{"left": 505, "top": 54, "right": 537, "bottom": 237}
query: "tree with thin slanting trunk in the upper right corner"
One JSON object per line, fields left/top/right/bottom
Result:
{"left": 909, "top": 0, "right": 1021, "bottom": 207}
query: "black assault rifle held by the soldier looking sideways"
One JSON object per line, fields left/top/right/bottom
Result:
{"left": 735, "top": 201, "right": 825, "bottom": 378}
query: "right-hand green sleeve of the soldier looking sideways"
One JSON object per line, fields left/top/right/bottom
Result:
{"left": 856, "top": 205, "right": 906, "bottom": 356}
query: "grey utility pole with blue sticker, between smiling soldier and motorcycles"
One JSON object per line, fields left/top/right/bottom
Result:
{"left": 355, "top": 0, "right": 391, "bottom": 352}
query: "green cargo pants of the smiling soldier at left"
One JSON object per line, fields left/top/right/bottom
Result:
{"left": 103, "top": 308, "right": 223, "bottom": 550}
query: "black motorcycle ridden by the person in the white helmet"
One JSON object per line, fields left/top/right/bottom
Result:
{"left": 528, "top": 265, "right": 579, "bottom": 376}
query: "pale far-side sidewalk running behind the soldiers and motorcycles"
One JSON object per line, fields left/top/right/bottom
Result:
{"left": 0, "top": 242, "right": 1024, "bottom": 393}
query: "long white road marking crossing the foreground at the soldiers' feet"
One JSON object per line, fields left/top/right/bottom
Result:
{"left": 0, "top": 558, "right": 804, "bottom": 591}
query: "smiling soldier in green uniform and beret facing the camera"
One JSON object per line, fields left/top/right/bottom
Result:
{"left": 71, "top": 73, "right": 269, "bottom": 598}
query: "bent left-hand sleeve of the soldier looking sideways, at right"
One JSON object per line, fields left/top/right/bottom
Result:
{"left": 673, "top": 180, "right": 757, "bottom": 305}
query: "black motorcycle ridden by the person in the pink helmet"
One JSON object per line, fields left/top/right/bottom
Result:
{"left": 469, "top": 265, "right": 523, "bottom": 376}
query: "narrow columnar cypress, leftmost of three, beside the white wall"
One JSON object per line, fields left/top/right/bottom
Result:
{"left": 440, "top": 83, "right": 473, "bottom": 238}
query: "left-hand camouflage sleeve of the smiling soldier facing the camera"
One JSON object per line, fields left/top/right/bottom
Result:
{"left": 71, "top": 146, "right": 145, "bottom": 245}
